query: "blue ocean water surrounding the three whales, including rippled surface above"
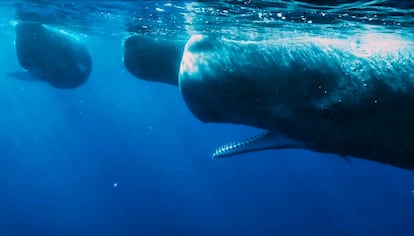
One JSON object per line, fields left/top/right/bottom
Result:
{"left": 0, "top": 0, "right": 414, "bottom": 236}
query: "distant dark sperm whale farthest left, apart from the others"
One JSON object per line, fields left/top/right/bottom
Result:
{"left": 16, "top": 22, "right": 92, "bottom": 89}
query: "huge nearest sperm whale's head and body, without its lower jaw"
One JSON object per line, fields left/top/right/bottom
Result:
{"left": 179, "top": 35, "right": 414, "bottom": 169}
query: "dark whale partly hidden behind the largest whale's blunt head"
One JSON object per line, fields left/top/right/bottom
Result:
{"left": 123, "top": 34, "right": 185, "bottom": 85}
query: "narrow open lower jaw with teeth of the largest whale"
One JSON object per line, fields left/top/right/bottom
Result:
{"left": 212, "top": 131, "right": 306, "bottom": 159}
